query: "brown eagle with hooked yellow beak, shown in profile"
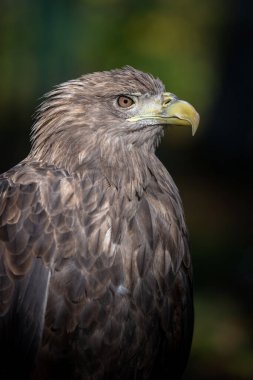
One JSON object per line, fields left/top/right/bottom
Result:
{"left": 0, "top": 66, "right": 199, "bottom": 380}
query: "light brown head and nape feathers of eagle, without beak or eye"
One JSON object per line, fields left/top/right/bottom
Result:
{"left": 29, "top": 66, "right": 164, "bottom": 196}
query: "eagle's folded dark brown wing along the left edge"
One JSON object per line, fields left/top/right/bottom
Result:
{"left": 0, "top": 165, "right": 73, "bottom": 378}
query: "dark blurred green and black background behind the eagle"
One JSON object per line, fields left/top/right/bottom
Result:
{"left": 0, "top": 0, "right": 253, "bottom": 380}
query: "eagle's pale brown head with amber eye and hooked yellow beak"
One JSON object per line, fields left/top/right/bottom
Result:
{"left": 30, "top": 66, "right": 199, "bottom": 181}
